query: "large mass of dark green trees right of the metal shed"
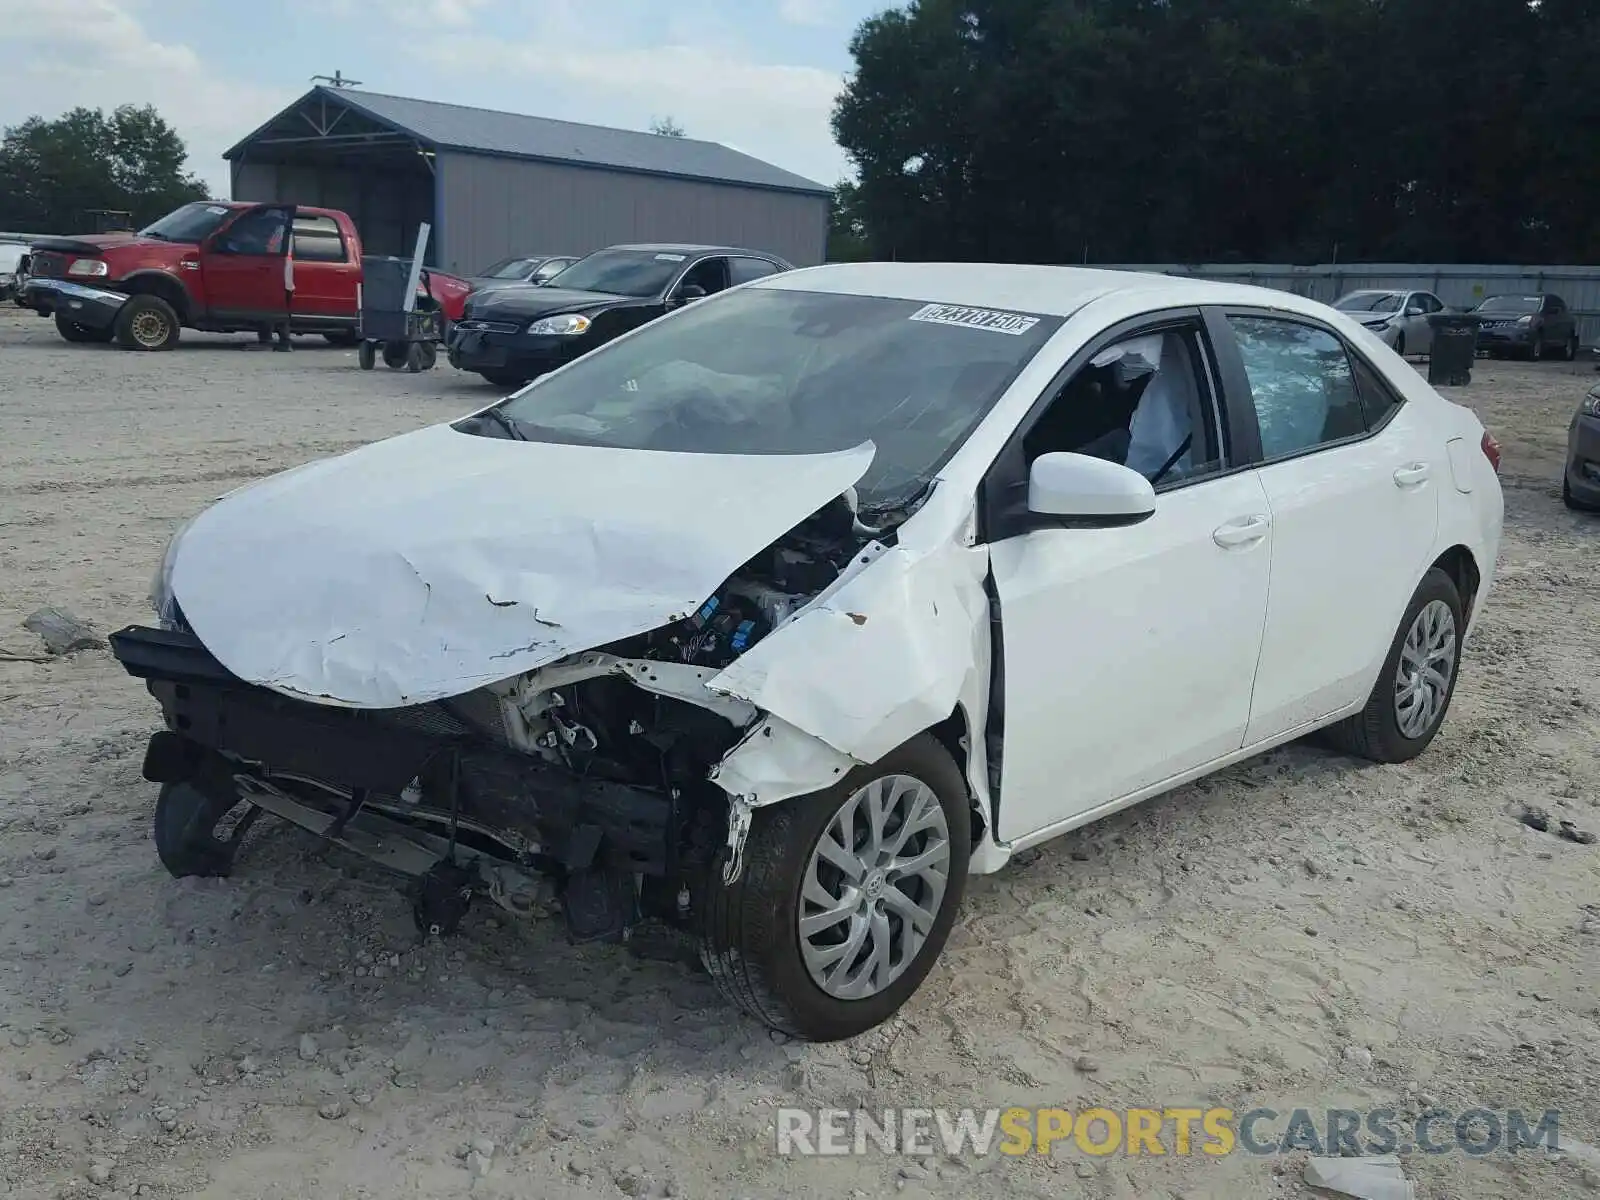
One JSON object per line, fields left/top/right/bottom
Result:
{"left": 834, "top": 0, "right": 1600, "bottom": 262}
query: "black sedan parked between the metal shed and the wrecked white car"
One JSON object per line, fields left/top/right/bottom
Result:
{"left": 448, "top": 245, "right": 794, "bottom": 387}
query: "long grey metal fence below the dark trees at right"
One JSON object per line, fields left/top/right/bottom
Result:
{"left": 1110, "top": 262, "right": 1600, "bottom": 346}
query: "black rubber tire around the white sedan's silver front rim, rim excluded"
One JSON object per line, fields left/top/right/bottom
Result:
{"left": 701, "top": 734, "right": 971, "bottom": 1042}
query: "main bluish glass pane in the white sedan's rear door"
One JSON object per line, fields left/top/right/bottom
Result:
{"left": 1227, "top": 317, "right": 1366, "bottom": 461}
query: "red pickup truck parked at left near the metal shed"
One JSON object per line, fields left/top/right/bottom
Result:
{"left": 22, "top": 200, "right": 470, "bottom": 350}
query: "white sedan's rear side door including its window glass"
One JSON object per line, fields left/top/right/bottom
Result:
{"left": 1221, "top": 312, "right": 1450, "bottom": 746}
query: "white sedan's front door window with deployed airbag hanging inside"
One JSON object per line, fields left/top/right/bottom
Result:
{"left": 1022, "top": 323, "right": 1222, "bottom": 490}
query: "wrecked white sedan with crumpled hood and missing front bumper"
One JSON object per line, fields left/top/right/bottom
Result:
{"left": 112, "top": 264, "right": 1502, "bottom": 1040}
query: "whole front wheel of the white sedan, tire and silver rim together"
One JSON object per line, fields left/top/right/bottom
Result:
{"left": 701, "top": 734, "right": 971, "bottom": 1042}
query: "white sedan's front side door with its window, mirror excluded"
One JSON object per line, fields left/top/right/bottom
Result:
{"left": 986, "top": 315, "right": 1272, "bottom": 842}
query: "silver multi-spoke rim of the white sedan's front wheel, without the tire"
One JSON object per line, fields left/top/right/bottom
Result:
{"left": 797, "top": 774, "right": 950, "bottom": 1000}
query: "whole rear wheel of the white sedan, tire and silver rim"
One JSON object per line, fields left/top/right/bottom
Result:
{"left": 1322, "top": 566, "right": 1466, "bottom": 763}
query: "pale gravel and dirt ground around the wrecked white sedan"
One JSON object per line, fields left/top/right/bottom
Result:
{"left": 0, "top": 310, "right": 1600, "bottom": 1200}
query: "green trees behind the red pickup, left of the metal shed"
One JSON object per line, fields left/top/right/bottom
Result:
{"left": 0, "top": 104, "right": 208, "bottom": 234}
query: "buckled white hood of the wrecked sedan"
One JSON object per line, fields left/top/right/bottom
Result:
{"left": 171, "top": 426, "right": 874, "bottom": 709}
